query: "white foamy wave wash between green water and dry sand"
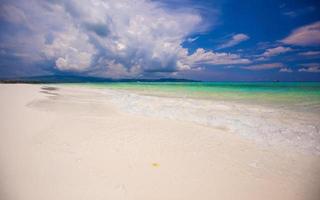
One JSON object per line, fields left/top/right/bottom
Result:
{"left": 105, "top": 89, "right": 320, "bottom": 154}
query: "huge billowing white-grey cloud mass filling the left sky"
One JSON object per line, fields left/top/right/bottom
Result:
{"left": 0, "top": 0, "right": 250, "bottom": 77}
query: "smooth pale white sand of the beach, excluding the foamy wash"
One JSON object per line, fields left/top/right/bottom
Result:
{"left": 0, "top": 85, "right": 320, "bottom": 200}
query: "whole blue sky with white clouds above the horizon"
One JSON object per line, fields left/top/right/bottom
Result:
{"left": 0, "top": 0, "right": 320, "bottom": 81}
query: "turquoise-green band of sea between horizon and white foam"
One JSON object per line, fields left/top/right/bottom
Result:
{"left": 71, "top": 82, "right": 320, "bottom": 112}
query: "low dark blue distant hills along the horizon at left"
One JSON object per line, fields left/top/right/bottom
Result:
{"left": 0, "top": 75, "right": 199, "bottom": 83}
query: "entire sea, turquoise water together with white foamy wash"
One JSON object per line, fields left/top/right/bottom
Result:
{"left": 65, "top": 82, "right": 320, "bottom": 154}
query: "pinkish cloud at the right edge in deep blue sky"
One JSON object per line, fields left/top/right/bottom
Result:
{"left": 282, "top": 21, "right": 320, "bottom": 46}
